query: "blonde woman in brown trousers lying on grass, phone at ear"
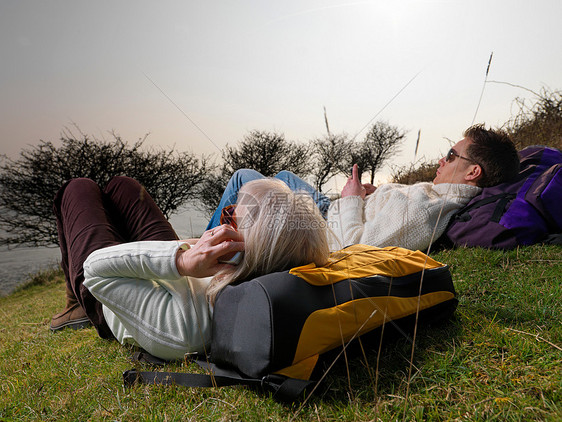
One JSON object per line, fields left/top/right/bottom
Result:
{"left": 51, "top": 177, "right": 328, "bottom": 359}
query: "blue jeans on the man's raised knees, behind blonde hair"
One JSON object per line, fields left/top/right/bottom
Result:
{"left": 206, "top": 169, "right": 330, "bottom": 230}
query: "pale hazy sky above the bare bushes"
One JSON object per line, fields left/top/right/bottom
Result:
{"left": 0, "top": 0, "right": 562, "bottom": 181}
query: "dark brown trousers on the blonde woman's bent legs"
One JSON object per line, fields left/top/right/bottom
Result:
{"left": 53, "top": 176, "right": 178, "bottom": 338}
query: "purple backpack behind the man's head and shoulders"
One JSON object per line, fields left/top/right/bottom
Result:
{"left": 441, "top": 146, "right": 562, "bottom": 249}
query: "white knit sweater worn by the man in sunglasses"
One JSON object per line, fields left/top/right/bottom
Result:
{"left": 328, "top": 183, "right": 481, "bottom": 250}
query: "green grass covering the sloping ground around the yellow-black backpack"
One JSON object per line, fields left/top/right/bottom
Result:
{"left": 0, "top": 246, "right": 562, "bottom": 421}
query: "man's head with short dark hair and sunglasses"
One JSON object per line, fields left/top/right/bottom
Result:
{"left": 433, "top": 125, "right": 519, "bottom": 187}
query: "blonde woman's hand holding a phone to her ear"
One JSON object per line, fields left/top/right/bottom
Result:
{"left": 176, "top": 224, "right": 244, "bottom": 277}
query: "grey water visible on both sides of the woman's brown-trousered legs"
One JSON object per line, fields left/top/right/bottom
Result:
{"left": 0, "top": 208, "right": 208, "bottom": 296}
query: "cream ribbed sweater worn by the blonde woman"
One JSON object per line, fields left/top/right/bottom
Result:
{"left": 84, "top": 241, "right": 211, "bottom": 359}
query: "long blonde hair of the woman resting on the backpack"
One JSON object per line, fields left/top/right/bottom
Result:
{"left": 207, "top": 179, "right": 329, "bottom": 304}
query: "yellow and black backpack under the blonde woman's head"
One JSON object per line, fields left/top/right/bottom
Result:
{"left": 124, "top": 245, "right": 457, "bottom": 400}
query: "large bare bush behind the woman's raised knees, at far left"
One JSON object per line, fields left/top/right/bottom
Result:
{"left": 0, "top": 131, "right": 212, "bottom": 246}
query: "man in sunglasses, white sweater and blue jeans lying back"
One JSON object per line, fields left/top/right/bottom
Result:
{"left": 207, "top": 125, "right": 519, "bottom": 250}
